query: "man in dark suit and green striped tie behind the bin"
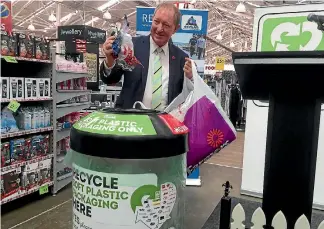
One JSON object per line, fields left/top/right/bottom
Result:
{"left": 100, "top": 2, "right": 192, "bottom": 110}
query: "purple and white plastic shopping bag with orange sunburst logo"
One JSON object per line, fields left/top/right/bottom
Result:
{"left": 165, "top": 62, "right": 236, "bottom": 174}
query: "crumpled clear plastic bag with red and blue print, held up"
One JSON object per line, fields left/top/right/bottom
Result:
{"left": 112, "top": 15, "right": 141, "bottom": 71}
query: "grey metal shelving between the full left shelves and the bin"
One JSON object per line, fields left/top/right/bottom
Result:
{"left": 53, "top": 63, "right": 91, "bottom": 195}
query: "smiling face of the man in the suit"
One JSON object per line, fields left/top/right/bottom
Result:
{"left": 151, "top": 8, "right": 179, "bottom": 47}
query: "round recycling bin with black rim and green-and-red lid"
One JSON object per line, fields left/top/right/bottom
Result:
{"left": 66, "top": 109, "right": 188, "bottom": 229}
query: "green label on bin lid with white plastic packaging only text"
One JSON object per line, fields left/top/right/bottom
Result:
{"left": 73, "top": 112, "right": 156, "bottom": 136}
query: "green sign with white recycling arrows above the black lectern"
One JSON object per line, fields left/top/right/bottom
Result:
{"left": 261, "top": 16, "right": 324, "bottom": 51}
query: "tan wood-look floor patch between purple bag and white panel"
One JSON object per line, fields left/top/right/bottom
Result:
{"left": 207, "top": 132, "right": 245, "bottom": 169}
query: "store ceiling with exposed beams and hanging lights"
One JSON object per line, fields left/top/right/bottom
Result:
{"left": 12, "top": 0, "right": 322, "bottom": 63}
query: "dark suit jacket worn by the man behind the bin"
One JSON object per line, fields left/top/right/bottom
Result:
{"left": 100, "top": 36, "right": 188, "bottom": 109}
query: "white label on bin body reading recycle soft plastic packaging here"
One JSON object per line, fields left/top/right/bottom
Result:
{"left": 73, "top": 164, "right": 177, "bottom": 229}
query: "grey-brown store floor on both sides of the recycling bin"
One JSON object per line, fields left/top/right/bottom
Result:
{"left": 1, "top": 164, "right": 241, "bottom": 229}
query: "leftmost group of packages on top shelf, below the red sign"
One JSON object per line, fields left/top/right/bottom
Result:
{"left": 1, "top": 31, "right": 18, "bottom": 56}
